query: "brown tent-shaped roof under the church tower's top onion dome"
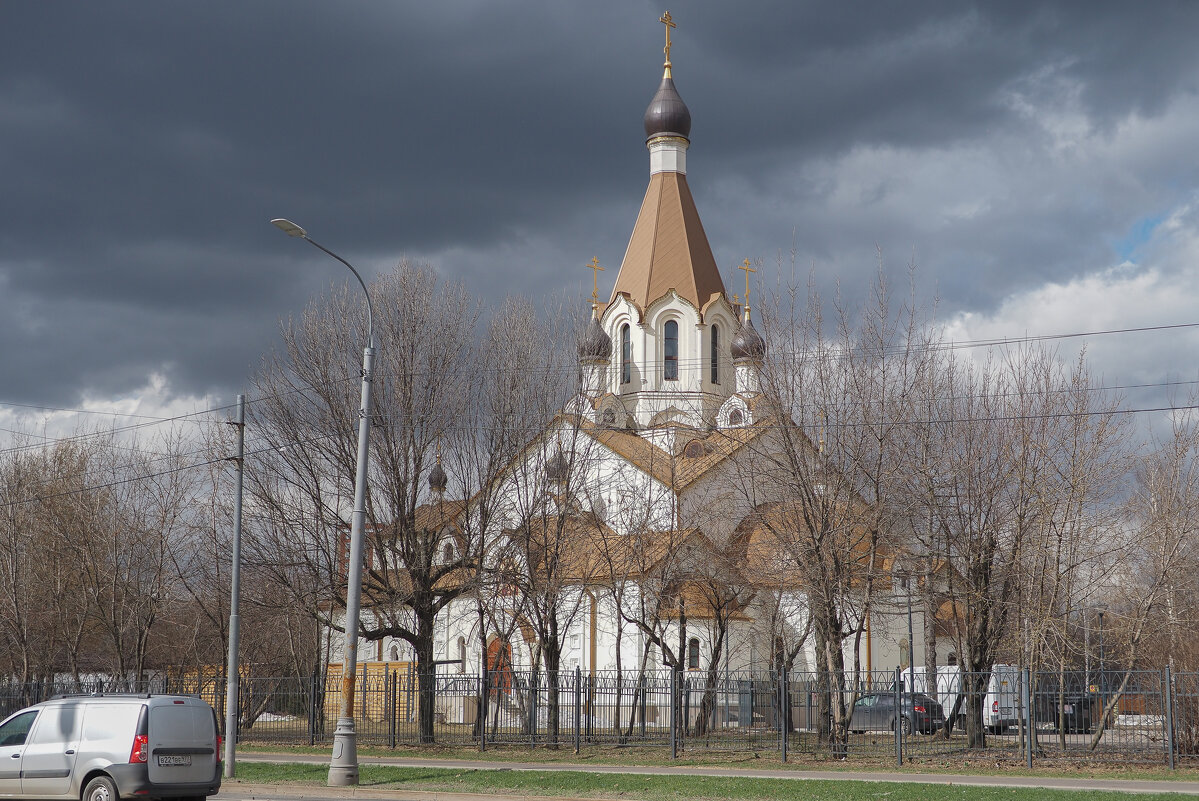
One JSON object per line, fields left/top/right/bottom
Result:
{"left": 611, "top": 171, "right": 724, "bottom": 308}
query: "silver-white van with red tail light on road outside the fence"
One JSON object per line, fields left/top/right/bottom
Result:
{"left": 0, "top": 694, "right": 221, "bottom": 801}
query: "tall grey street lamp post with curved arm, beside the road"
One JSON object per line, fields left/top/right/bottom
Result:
{"left": 271, "top": 219, "right": 375, "bottom": 787}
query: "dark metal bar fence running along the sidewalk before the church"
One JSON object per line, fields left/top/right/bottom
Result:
{"left": 9, "top": 664, "right": 1199, "bottom": 767}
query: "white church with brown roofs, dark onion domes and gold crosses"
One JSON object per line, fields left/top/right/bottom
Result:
{"left": 350, "top": 17, "right": 899, "bottom": 700}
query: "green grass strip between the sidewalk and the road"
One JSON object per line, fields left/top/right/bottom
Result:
{"left": 237, "top": 763, "right": 1179, "bottom": 801}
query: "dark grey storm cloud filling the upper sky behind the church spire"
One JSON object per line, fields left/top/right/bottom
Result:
{"left": 0, "top": 1, "right": 1199, "bottom": 404}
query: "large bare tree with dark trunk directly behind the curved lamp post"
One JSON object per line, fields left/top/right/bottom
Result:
{"left": 248, "top": 261, "right": 480, "bottom": 742}
